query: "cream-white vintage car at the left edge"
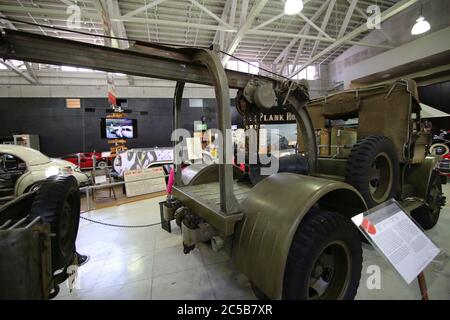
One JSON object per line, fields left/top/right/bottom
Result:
{"left": 0, "top": 144, "right": 90, "bottom": 198}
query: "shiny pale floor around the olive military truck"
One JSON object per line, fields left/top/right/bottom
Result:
{"left": 56, "top": 184, "right": 450, "bottom": 300}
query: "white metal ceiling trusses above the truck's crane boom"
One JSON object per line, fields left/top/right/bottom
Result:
{"left": 0, "top": 0, "right": 408, "bottom": 76}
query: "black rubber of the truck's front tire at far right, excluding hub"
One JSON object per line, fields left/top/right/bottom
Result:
{"left": 411, "top": 171, "right": 442, "bottom": 230}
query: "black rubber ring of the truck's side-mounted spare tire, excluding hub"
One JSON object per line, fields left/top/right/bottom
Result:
{"left": 345, "top": 135, "right": 400, "bottom": 208}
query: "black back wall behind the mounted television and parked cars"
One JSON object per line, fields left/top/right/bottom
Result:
{"left": 0, "top": 98, "right": 236, "bottom": 157}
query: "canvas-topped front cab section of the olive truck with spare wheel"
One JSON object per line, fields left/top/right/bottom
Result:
{"left": 307, "top": 80, "right": 446, "bottom": 230}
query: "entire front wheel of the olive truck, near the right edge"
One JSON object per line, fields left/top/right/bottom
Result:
{"left": 411, "top": 171, "right": 445, "bottom": 230}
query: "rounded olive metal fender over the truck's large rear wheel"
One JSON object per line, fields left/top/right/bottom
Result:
{"left": 232, "top": 173, "right": 367, "bottom": 299}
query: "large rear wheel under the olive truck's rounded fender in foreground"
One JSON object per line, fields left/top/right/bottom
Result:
{"left": 283, "top": 209, "right": 362, "bottom": 300}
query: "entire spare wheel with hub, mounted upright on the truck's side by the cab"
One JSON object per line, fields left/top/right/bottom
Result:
{"left": 345, "top": 135, "right": 400, "bottom": 208}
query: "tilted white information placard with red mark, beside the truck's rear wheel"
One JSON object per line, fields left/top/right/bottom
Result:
{"left": 352, "top": 201, "right": 440, "bottom": 284}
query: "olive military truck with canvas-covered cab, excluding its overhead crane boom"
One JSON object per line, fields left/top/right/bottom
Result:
{"left": 163, "top": 75, "right": 444, "bottom": 299}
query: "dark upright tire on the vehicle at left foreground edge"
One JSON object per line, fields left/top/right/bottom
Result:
{"left": 30, "top": 176, "right": 80, "bottom": 271}
